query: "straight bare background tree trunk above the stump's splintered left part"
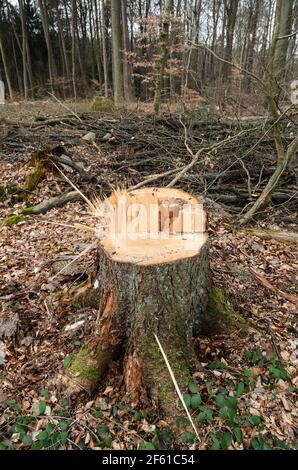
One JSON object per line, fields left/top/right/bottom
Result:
{"left": 111, "top": 0, "right": 124, "bottom": 106}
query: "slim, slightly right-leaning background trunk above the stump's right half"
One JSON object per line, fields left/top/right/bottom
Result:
{"left": 154, "top": 0, "right": 174, "bottom": 114}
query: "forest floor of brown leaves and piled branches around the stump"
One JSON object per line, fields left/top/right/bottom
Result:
{"left": 0, "top": 102, "right": 298, "bottom": 450}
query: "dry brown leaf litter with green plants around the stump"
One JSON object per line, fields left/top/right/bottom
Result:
{"left": 0, "top": 104, "right": 298, "bottom": 450}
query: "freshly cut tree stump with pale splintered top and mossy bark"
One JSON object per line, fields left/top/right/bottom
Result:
{"left": 65, "top": 188, "right": 209, "bottom": 410}
